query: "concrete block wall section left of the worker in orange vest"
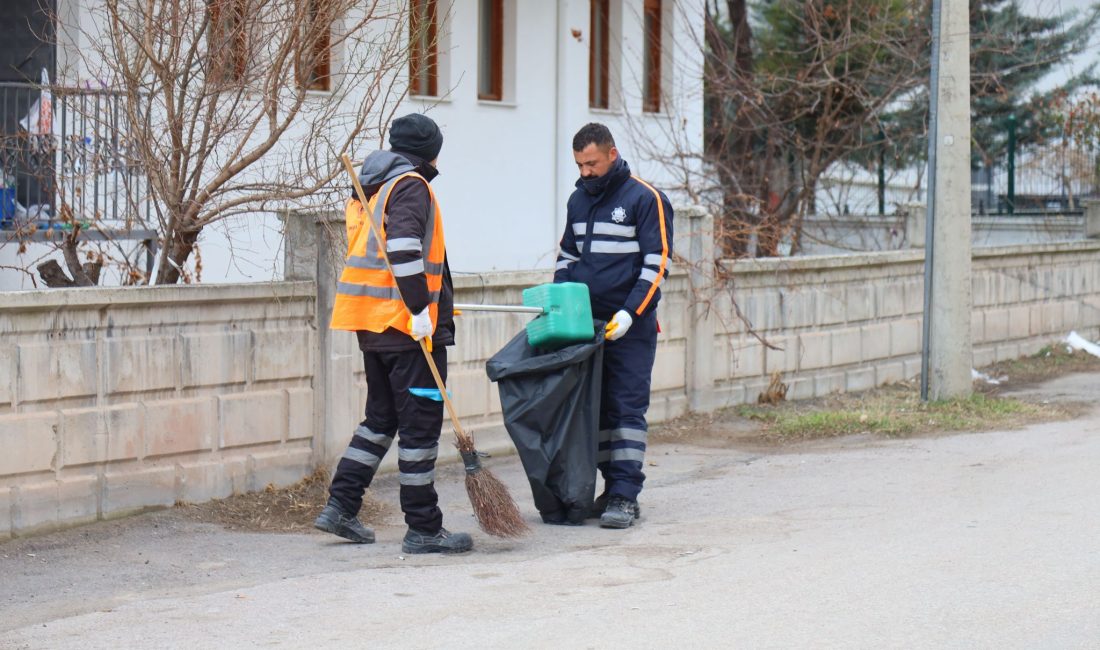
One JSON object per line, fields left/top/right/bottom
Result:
{"left": 0, "top": 283, "right": 317, "bottom": 538}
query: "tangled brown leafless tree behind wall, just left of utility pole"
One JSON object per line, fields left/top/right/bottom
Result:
{"left": 705, "top": 0, "right": 927, "bottom": 256}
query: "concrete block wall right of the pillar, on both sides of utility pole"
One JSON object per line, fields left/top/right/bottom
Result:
{"left": 712, "top": 242, "right": 1100, "bottom": 406}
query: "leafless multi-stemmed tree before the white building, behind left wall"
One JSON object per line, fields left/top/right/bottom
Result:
{"left": 46, "top": 0, "right": 408, "bottom": 284}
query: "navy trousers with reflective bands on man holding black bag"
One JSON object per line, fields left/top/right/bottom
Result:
{"left": 597, "top": 310, "right": 657, "bottom": 499}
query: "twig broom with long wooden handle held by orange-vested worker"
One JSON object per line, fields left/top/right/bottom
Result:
{"left": 341, "top": 154, "right": 529, "bottom": 537}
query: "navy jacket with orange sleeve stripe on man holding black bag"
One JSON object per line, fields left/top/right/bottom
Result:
{"left": 553, "top": 158, "right": 672, "bottom": 320}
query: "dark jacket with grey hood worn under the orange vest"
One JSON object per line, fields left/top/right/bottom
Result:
{"left": 352, "top": 152, "right": 454, "bottom": 352}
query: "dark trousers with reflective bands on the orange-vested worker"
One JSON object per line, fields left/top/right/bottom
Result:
{"left": 329, "top": 346, "right": 447, "bottom": 532}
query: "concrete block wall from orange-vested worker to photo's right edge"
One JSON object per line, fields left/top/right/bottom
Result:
{"left": 431, "top": 238, "right": 1100, "bottom": 437}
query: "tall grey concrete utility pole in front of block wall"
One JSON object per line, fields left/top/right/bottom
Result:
{"left": 921, "top": 0, "right": 974, "bottom": 400}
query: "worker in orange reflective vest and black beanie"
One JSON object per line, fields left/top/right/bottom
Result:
{"left": 314, "top": 113, "right": 473, "bottom": 553}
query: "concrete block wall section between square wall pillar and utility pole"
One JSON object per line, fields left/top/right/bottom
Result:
{"left": 712, "top": 251, "right": 923, "bottom": 406}
